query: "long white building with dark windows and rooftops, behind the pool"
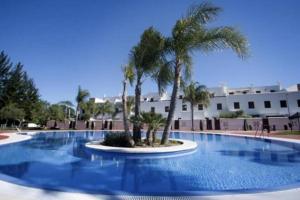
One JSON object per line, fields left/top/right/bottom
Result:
{"left": 91, "top": 84, "right": 300, "bottom": 120}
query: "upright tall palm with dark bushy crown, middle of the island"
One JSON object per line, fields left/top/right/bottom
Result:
{"left": 130, "top": 27, "right": 164, "bottom": 143}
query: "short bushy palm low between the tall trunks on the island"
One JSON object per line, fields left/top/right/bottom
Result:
{"left": 140, "top": 112, "right": 166, "bottom": 145}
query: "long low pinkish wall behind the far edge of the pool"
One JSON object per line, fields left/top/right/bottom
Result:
{"left": 47, "top": 117, "right": 299, "bottom": 131}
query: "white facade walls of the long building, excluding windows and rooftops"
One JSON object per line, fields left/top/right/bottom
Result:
{"left": 141, "top": 92, "right": 300, "bottom": 120}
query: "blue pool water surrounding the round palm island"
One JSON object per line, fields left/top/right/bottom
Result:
{"left": 0, "top": 132, "right": 300, "bottom": 195}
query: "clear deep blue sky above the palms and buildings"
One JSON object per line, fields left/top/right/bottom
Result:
{"left": 0, "top": 0, "right": 300, "bottom": 103}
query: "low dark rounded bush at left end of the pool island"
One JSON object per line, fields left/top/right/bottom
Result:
{"left": 102, "top": 132, "right": 132, "bottom": 147}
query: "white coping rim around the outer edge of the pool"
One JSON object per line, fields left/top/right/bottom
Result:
{"left": 0, "top": 130, "right": 300, "bottom": 200}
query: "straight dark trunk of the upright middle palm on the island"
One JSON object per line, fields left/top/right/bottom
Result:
{"left": 133, "top": 77, "right": 142, "bottom": 143}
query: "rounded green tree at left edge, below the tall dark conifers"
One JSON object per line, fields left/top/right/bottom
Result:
{"left": 0, "top": 103, "right": 25, "bottom": 126}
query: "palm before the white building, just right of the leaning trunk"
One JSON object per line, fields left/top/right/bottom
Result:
{"left": 183, "top": 81, "right": 210, "bottom": 131}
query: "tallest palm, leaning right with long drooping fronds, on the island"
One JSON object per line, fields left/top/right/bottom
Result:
{"left": 161, "top": 2, "right": 248, "bottom": 144}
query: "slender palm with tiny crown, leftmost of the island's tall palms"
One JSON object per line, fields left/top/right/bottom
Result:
{"left": 122, "top": 65, "right": 134, "bottom": 134}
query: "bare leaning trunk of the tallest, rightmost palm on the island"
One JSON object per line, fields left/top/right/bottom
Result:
{"left": 161, "top": 60, "right": 181, "bottom": 144}
